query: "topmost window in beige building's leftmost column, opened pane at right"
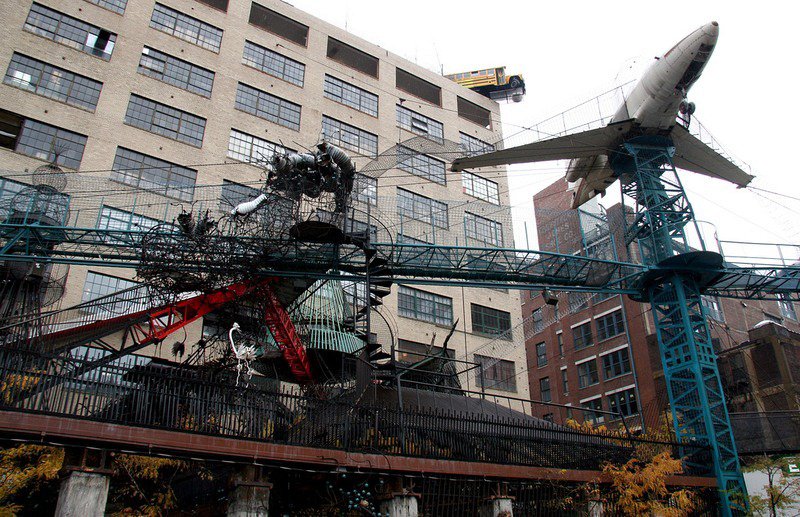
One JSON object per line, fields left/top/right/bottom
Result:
{"left": 25, "top": 3, "right": 117, "bottom": 60}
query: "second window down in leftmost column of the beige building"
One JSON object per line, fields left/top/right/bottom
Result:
{"left": 4, "top": 52, "right": 103, "bottom": 111}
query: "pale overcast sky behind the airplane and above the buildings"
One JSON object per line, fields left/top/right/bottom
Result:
{"left": 290, "top": 0, "right": 800, "bottom": 258}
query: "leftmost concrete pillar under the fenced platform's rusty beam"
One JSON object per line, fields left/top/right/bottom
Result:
{"left": 55, "top": 470, "right": 111, "bottom": 517}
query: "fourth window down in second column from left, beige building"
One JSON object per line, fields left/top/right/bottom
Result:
{"left": 111, "top": 147, "right": 197, "bottom": 201}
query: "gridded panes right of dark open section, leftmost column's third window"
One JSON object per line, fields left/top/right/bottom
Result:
{"left": 15, "top": 119, "right": 86, "bottom": 169}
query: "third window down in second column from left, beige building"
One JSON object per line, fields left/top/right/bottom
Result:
{"left": 125, "top": 94, "right": 206, "bottom": 147}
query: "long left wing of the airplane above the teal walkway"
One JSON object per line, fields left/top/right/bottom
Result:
{"left": 452, "top": 121, "right": 633, "bottom": 172}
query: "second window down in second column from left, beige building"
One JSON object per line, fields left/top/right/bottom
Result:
{"left": 139, "top": 47, "right": 214, "bottom": 97}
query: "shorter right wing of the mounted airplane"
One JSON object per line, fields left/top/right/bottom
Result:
{"left": 672, "top": 125, "right": 753, "bottom": 187}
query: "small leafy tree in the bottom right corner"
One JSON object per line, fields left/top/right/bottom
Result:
{"left": 742, "top": 455, "right": 800, "bottom": 517}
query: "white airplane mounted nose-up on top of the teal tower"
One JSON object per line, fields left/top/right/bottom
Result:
{"left": 452, "top": 22, "right": 753, "bottom": 208}
